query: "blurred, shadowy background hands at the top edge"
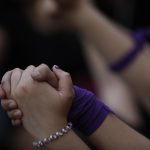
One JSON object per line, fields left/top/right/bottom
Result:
{"left": 28, "top": 0, "right": 88, "bottom": 31}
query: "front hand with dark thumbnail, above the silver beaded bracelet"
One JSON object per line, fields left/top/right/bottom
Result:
{"left": 0, "top": 66, "right": 74, "bottom": 138}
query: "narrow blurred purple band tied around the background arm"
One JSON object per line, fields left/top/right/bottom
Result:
{"left": 109, "top": 28, "right": 150, "bottom": 72}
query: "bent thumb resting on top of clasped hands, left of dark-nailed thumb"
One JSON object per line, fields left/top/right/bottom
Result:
{"left": 31, "top": 64, "right": 58, "bottom": 88}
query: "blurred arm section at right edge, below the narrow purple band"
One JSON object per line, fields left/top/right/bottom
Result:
{"left": 120, "top": 46, "right": 150, "bottom": 112}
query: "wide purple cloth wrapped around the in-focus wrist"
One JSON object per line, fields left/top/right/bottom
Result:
{"left": 68, "top": 86, "right": 112, "bottom": 136}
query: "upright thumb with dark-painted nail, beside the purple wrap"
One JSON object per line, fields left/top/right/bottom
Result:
{"left": 53, "top": 65, "right": 73, "bottom": 98}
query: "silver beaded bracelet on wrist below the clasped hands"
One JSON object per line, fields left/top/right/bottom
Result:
{"left": 32, "top": 122, "right": 72, "bottom": 150}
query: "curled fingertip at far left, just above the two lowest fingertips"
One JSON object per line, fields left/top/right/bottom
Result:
{"left": 1, "top": 99, "right": 18, "bottom": 111}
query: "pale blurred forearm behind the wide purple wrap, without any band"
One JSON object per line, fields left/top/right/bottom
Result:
{"left": 84, "top": 42, "right": 141, "bottom": 127}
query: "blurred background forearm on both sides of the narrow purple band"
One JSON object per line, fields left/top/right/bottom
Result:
{"left": 72, "top": 5, "right": 150, "bottom": 107}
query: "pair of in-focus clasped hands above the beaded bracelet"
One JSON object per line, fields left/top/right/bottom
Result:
{"left": 0, "top": 65, "right": 74, "bottom": 138}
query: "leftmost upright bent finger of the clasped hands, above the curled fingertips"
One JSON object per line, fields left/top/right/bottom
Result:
{"left": 1, "top": 71, "right": 12, "bottom": 98}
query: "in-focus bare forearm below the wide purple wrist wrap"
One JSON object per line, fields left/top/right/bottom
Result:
{"left": 89, "top": 115, "right": 150, "bottom": 150}
